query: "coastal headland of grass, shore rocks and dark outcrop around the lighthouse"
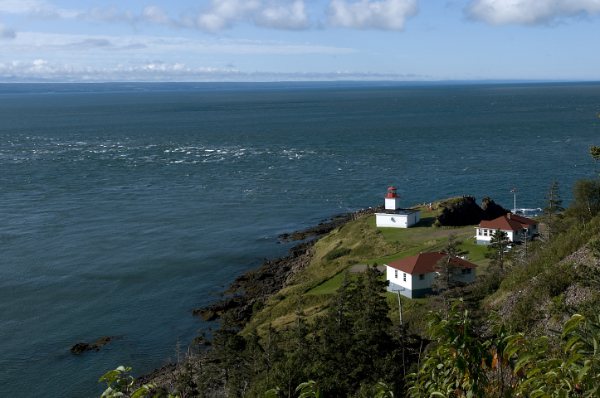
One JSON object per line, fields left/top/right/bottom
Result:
{"left": 137, "top": 196, "right": 506, "bottom": 385}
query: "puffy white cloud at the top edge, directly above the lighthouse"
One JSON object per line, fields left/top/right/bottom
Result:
{"left": 327, "top": 0, "right": 419, "bottom": 30}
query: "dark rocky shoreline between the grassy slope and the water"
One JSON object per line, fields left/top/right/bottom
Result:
{"left": 193, "top": 206, "right": 383, "bottom": 327}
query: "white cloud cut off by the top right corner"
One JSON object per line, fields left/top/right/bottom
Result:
{"left": 464, "top": 0, "right": 600, "bottom": 26}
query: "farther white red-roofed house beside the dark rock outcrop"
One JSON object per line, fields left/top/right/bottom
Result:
{"left": 475, "top": 213, "right": 539, "bottom": 245}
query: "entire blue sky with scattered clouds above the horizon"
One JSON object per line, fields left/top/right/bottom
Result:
{"left": 0, "top": 0, "right": 600, "bottom": 82}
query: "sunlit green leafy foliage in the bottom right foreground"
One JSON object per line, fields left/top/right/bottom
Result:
{"left": 408, "top": 300, "right": 600, "bottom": 398}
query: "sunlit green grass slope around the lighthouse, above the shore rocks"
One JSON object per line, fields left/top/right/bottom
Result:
{"left": 242, "top": 208, "right": 486, "bottom": 334}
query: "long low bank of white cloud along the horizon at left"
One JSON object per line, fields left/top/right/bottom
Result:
{"left": 0, "top": 59, "right": 423, "bottom": 82}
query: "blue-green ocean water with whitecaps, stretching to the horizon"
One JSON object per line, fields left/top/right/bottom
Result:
{"left": 0, "top": 84, "right": 600, "bottom": 397}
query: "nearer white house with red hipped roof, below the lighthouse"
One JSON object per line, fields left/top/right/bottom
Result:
{"left": 384, "top": 252, "right": 477, "bottom": 298}
